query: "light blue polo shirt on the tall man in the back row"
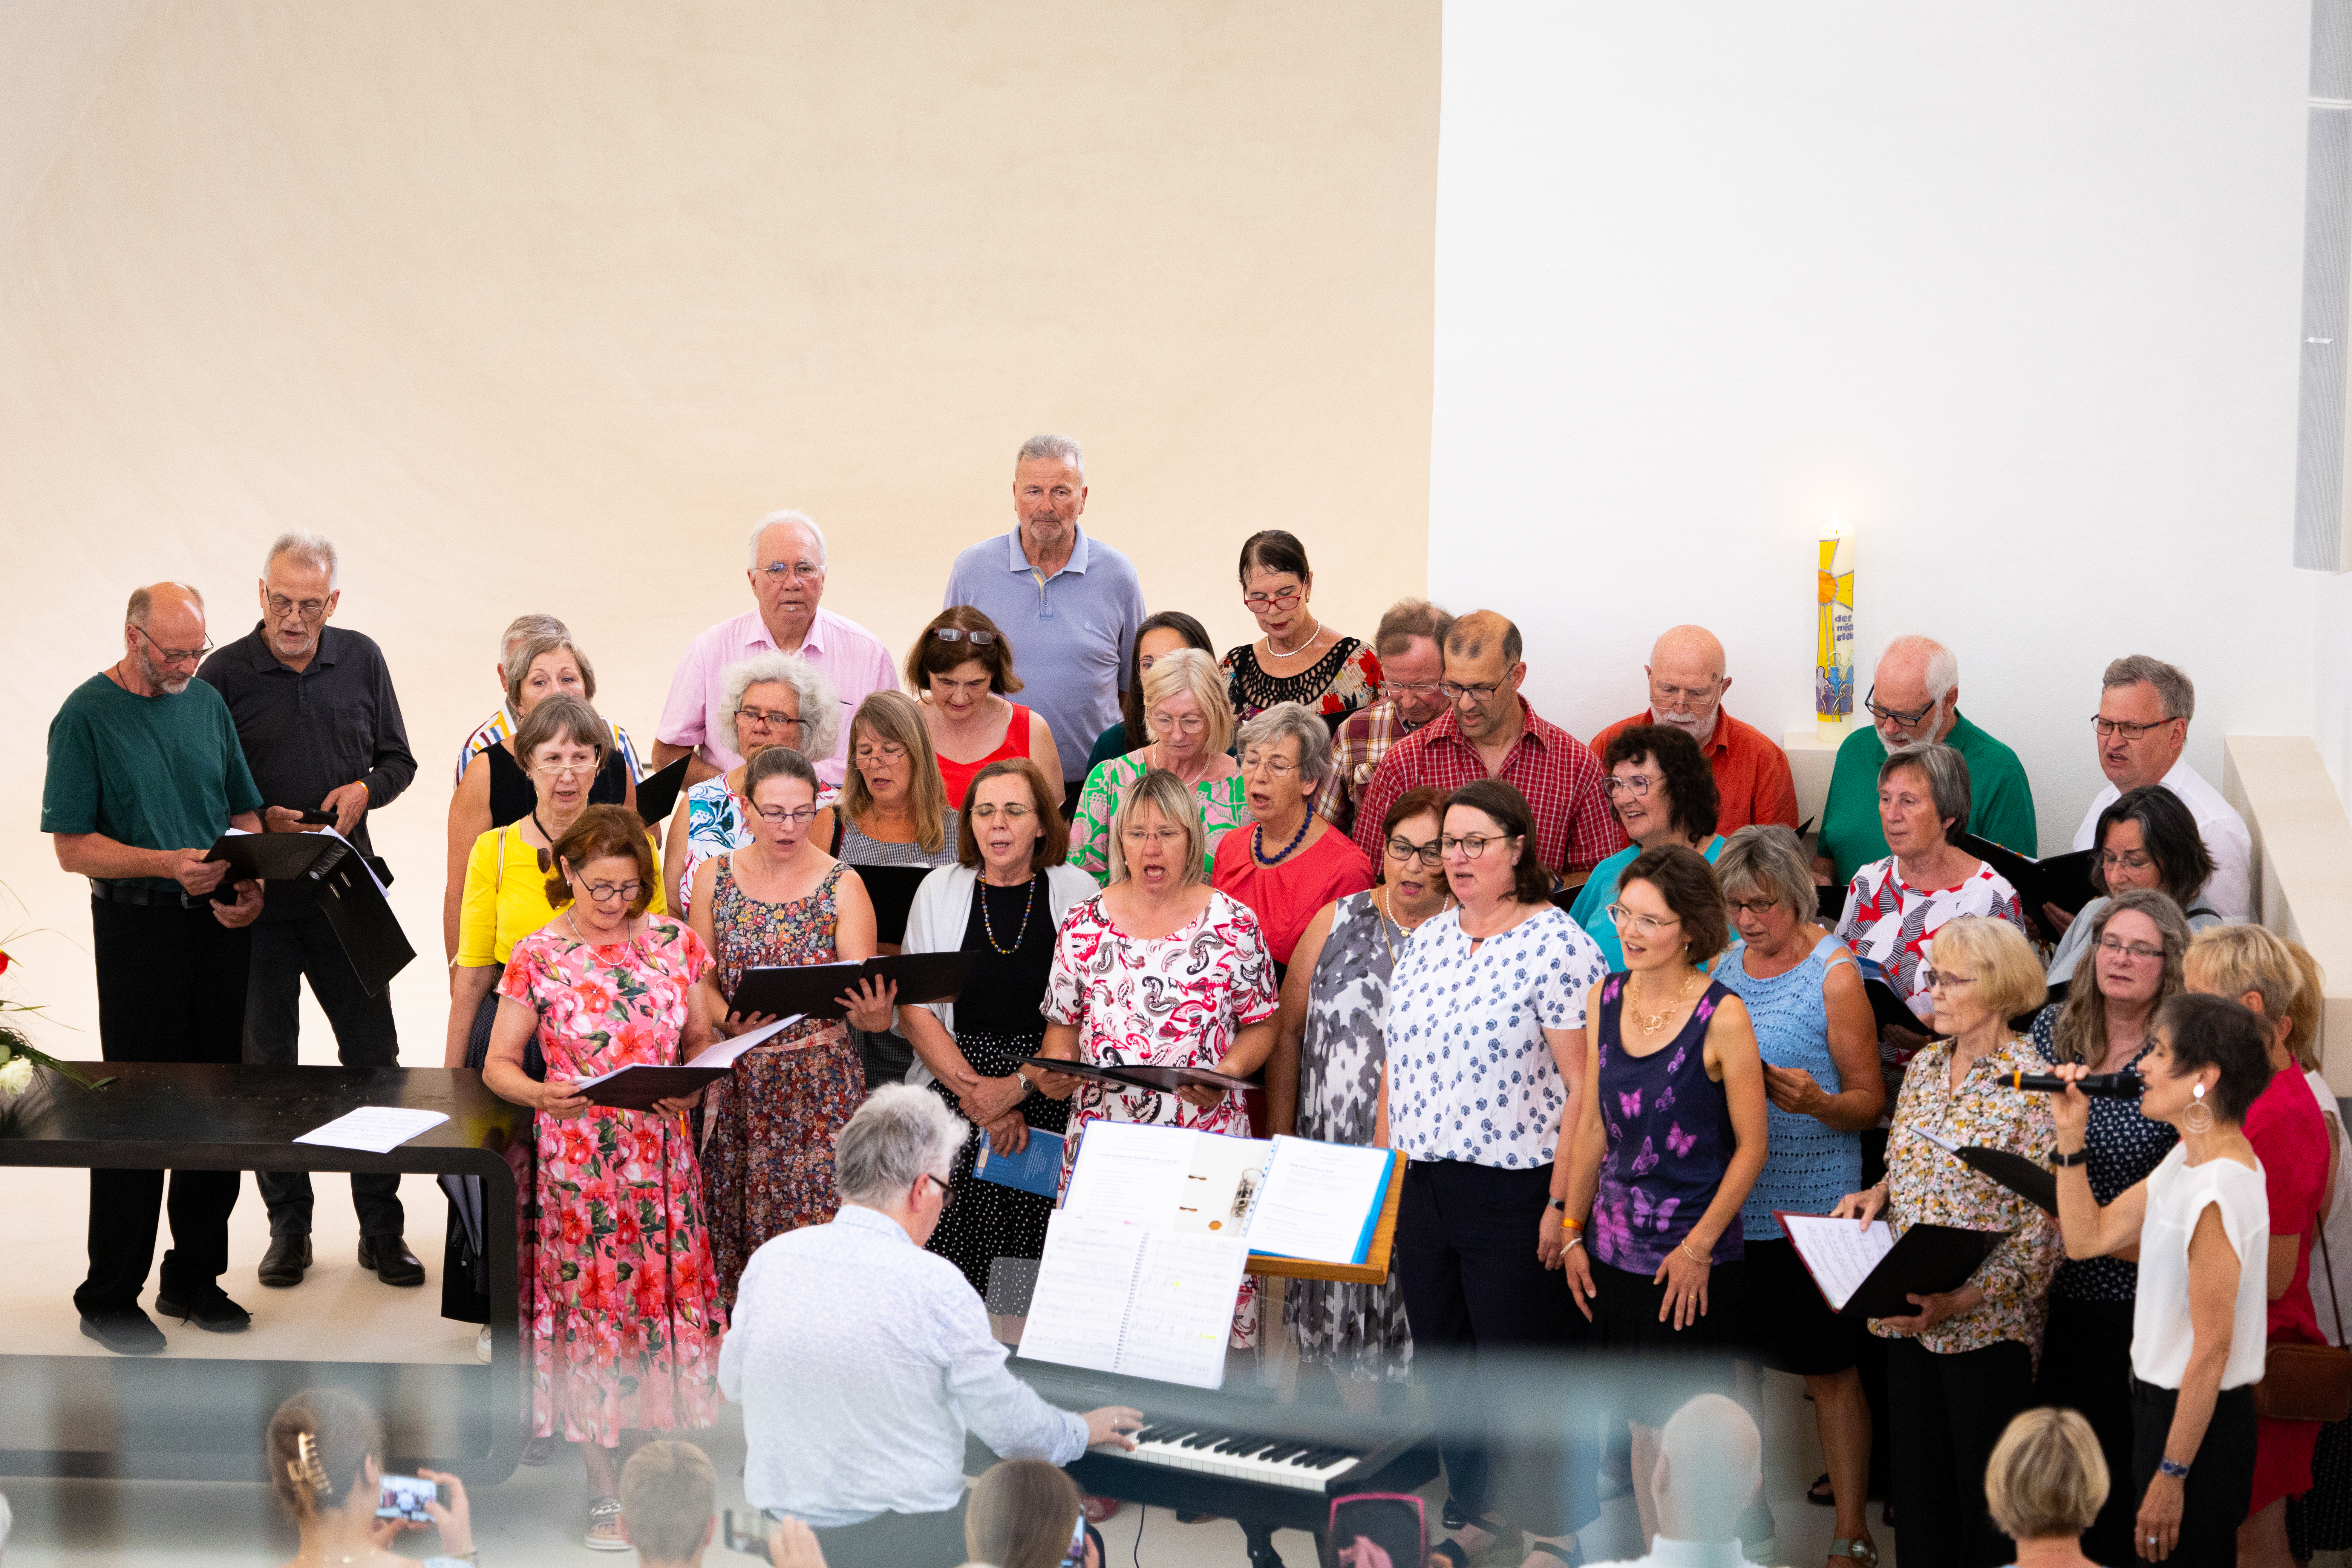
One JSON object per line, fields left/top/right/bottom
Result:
{"left": 945, "top": 527, "right": 1145, "bottom": 783}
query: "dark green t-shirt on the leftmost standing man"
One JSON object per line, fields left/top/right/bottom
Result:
{"left": 40, "top": 672, "right": 261, "bottom": 893}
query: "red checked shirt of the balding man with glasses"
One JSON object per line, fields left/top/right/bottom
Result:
{"left": 1355, "top": 698, "right": 1625, "bottom": 872}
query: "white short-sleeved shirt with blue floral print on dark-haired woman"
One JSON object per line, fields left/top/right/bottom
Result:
{"left": 1388, "top": 907, "right": 1609, "bottom": 1171}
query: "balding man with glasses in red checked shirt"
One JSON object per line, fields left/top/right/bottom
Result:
{"left": 1355, "top": 609, "right": 1625, "bottom": 886}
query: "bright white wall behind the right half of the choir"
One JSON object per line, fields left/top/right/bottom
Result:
{"left": 1430, "top": 0, "right": 2314, "bottom": 860}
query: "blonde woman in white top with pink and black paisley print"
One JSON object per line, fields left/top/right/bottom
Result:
{"left": 1040, "top": 769, "right": 1280, "bottom": 1347}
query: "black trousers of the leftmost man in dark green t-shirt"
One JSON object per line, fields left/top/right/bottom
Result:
{"left": 73, "top": 898, "right": 252, "bottom": 1317}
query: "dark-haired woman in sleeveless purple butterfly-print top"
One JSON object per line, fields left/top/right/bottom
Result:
{"left": 1564, "top": 844, "right": 1766, "bottom": 1535}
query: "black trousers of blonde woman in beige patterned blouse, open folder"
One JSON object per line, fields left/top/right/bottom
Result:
{"left": 1886, "top": 1340, "right": 2035, "bottom": 1568}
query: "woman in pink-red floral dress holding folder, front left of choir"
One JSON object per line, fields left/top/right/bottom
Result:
{"left": 482, "top": 806, "right": 727, "bottom": 1549}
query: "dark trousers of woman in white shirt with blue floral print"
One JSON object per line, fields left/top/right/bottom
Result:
{"left": 1395, "top": 1159, "right": 1602, "bottom": 1535}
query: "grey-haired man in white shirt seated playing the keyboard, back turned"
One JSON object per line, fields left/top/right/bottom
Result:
{"left": 720, "top": 1084, "right": 1143, "bottom": 1568}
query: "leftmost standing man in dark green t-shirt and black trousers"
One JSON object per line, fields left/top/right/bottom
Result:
{"left": 40, "top": 583, "right": 261, "bottom": 1354}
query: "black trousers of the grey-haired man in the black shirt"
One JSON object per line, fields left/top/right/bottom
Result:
{"left": 245, "top": 907, "right": 404, "bottom": 1237}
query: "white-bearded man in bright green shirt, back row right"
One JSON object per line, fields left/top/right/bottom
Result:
{"left": 1813, "top": 637, "right": 2037, "bottom": 884}
